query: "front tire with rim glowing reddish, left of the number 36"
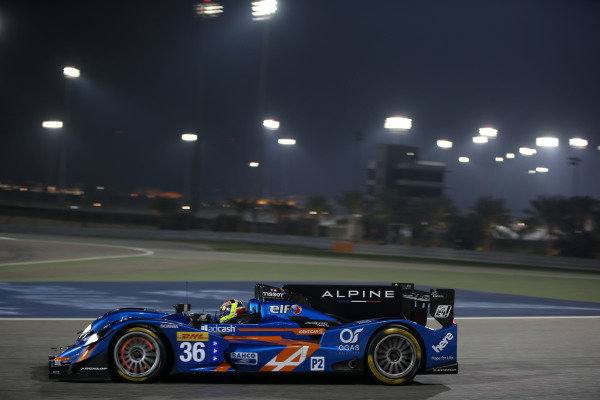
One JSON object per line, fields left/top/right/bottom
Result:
{"left": 109, "top": 325, "right": 168, "bottom": 383}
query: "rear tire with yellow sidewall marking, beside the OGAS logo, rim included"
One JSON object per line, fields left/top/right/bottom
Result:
{"left": 365, "top": 325, "right": 422, "bottom": 385}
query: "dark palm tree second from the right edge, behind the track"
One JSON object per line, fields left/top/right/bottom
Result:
{"left": 523, "top": 196, "right": 568, "bottom": 255}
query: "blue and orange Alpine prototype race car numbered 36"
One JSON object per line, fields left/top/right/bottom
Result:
{"left": 49, "top": 283, "right": 458, "bottom": 385}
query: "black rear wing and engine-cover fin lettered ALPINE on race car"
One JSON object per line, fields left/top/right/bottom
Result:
{"left": 254, "top": 283, "right": 454, "bottom": 327}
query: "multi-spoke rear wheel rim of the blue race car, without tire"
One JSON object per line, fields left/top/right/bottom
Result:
{"left": 373, "top": 334, "right": 417, "bottom": 379}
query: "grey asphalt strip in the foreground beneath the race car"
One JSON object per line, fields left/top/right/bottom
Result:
{"left": 0, "top": 318, "right": 600, "bottom": 400}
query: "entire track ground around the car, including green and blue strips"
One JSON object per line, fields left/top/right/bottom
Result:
{"left": 0, "top": 231, "right": 600, "bottom": 400}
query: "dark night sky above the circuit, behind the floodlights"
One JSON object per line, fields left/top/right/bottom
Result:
{"left": 0, "top": 0, "right": 600, "bottom": 210}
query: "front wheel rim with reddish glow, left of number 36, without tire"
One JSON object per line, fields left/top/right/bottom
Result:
{"left": 114, "top": 331, "right": 160, "bottom": 378}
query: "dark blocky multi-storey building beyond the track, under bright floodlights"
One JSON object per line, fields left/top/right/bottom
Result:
{"left": 367, "top": 144, "right": 446, "bottom": 197}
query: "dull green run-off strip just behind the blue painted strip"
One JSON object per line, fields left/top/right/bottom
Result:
{"left": 11, "top": 260, "right": 600, "bottom": 302}
